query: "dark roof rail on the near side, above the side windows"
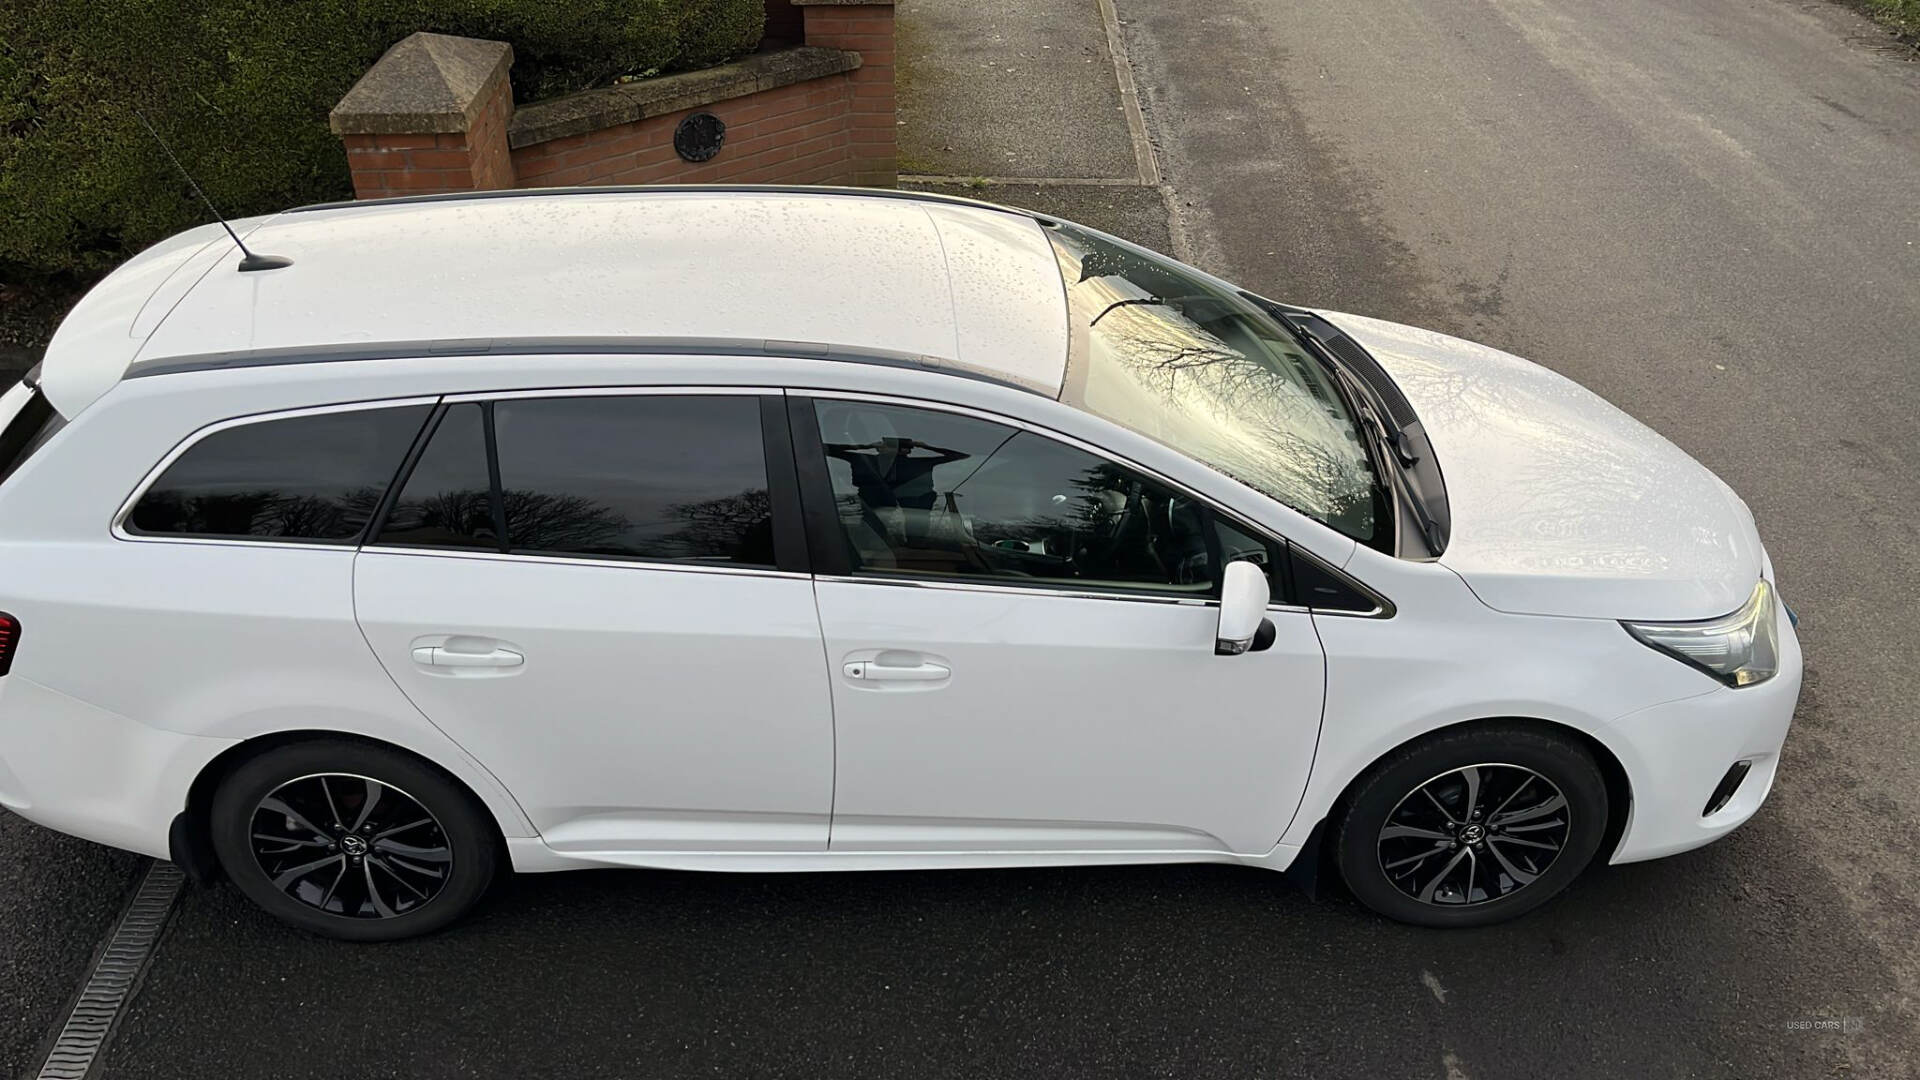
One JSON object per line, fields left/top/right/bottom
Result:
{"left": 127, "top": 336, "right": 1048, "bottom": 398}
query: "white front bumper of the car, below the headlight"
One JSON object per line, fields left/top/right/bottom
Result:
{"left": 1611, "top": 605, "right": 1801, "bottom": 863}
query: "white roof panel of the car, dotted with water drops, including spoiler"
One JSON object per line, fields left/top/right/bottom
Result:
{"left": 40, "top": 186, "right": 1068, "bottom": 417}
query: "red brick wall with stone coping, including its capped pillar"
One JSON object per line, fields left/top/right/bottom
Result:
{"left": 330, "top": 0, "right": 897, "bottom": 198}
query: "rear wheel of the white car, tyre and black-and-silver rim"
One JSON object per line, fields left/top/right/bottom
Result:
{"left": 211, "top": 740, "right": 497, "bottom": 942}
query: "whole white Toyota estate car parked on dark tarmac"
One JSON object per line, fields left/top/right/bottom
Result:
{"left": 0, "top": 188, "right": 1801, "bottom": 940}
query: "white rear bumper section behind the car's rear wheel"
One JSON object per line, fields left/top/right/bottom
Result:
{"left": 0, "top": 673, "right": 238, "bottom": 859}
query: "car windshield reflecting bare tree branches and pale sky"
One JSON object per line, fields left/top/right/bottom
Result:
{"left": 1046, "top": 223, "right": 1392, "bottom": 548}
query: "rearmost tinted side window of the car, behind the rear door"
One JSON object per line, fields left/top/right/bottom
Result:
{"left": 127, "top": 405, "right": 430, "bottom": 544}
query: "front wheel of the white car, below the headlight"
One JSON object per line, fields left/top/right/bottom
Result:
{"left": 1332, "top": 723, "right": 1609, "bottom": 926}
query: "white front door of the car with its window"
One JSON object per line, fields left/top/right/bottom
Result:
{"left": 793, "top": 398, "right": 1325, "bottom": 853}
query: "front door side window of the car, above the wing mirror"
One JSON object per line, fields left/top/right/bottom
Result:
{"left": 814, "top": 400, "right": 1279, "bottom": 598}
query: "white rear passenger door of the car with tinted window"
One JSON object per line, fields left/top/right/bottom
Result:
{"left": 353, "top": 390, "right": 833, "bottom": 851}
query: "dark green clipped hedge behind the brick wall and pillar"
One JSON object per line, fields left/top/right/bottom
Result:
{"left": 0, "top": 0, "right": 766, "bottom": 282}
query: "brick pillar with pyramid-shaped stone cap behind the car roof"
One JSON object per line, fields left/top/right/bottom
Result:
{"left": 326, "top": 33, "right": 513, "bottom": 198}
